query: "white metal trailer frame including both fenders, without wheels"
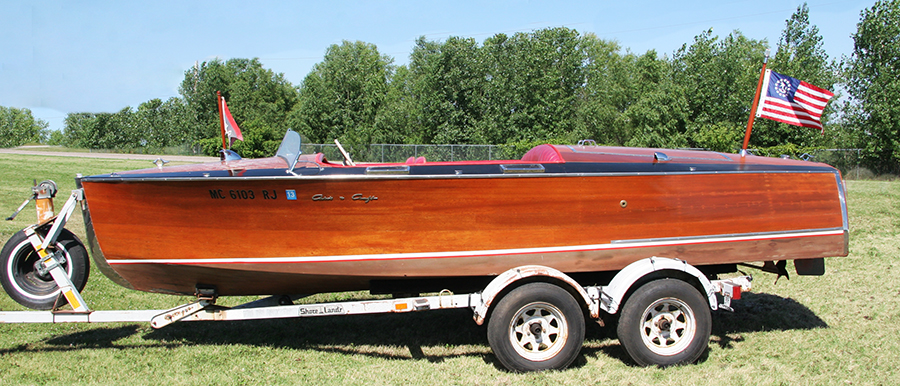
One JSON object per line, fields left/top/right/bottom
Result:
{"left": 0, "top": 255, "right": 752, "bottom": 329}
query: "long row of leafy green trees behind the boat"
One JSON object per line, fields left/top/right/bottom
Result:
{"left": 0, "top": 0, "right": 900, "bottom": 173}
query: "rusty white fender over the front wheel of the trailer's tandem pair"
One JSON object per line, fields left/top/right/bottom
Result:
{"left": 472, "top": 265, "right": 600, "bottom": 326}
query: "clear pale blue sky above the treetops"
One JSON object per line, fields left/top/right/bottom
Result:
{"left": 0, "top": 0, "right": 874, "bottom": 129}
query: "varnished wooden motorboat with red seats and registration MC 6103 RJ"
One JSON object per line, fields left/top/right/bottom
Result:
{"left": 79, "top": 133, "right": 848, "bottom": 295}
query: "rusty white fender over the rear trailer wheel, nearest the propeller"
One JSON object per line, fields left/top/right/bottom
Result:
{"left": 600, "top": 256, "right": 718, "bottom": 314}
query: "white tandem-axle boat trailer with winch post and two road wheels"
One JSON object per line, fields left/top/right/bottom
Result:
{"left": 0, "top": 184, "right": 752, "bottom": 371}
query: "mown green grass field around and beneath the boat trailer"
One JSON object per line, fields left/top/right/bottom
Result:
{"left": 0, "top": 154, "right": 900, "bottom": 385}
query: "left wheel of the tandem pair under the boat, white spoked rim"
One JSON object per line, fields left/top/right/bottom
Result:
{"left": 488, "top": 283, "right": 585, "bottom": 372}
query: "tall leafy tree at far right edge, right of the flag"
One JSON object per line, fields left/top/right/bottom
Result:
{"left": 844, "top": 0, "right": 900, "bottom": 173}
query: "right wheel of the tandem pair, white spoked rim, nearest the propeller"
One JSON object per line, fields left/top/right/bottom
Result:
{"left": 617, "top": 279, "right": 711, "bottom": 366}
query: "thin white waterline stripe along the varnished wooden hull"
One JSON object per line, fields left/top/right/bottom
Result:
{"left": 107, "top": 229, "right": 844, "bottom": 265}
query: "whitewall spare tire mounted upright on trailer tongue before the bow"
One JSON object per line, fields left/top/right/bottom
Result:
{"left": 0, "top": 229, "right": 90, "bottom": 310}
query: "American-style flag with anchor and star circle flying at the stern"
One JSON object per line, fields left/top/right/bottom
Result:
{"left": 756, "top": 70, "right": 834, "bottom": 130}
